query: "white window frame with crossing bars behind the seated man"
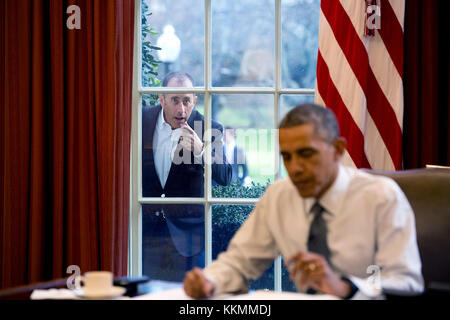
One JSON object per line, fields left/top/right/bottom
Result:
{"left": 128, "top": 0, "right": 314, "bottom": 291}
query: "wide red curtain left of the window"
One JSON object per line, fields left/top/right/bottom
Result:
{"left": 0, "top": 0, "right": 134, "bottom": 287}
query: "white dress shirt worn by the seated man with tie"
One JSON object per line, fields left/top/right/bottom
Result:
{"left": 205, "top": 165, "right": 423, "bottom": 299}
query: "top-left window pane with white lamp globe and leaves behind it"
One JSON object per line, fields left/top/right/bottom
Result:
{"left": 141, "top": 0, "right": 205, "bottom": 86}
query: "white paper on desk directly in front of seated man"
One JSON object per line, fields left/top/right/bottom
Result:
{"left": 227, "top": 290, "right": 340, "bottom": 300}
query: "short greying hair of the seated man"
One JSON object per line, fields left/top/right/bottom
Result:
{"left": 279, "top": 103, "right": 339, "bottom": 143}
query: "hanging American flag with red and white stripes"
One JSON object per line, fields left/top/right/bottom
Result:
{"left": 315, "top": 0, "right": 405, "bottom": 170}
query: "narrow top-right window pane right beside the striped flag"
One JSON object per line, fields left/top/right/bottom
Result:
{"left": 281, "top": 0, "right": 320, "bottom": 88}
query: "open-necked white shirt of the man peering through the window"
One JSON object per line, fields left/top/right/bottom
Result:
{"left": 153, "top": 110, "right": 181, "bottom": 188}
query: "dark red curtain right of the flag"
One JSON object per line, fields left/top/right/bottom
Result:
{"left": 403, "top": 0, "right": 450, "bottom": 169}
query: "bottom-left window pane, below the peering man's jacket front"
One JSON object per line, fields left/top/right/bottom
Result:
{"left": 142, "top": 204, "right": 205, "bottom": 281}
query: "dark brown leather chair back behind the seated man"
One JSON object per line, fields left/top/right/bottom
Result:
{"left": 367, "top": 168, "right": 450, "bottom": 294}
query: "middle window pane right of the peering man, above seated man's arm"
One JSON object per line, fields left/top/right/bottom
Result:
{"left": 212, "top": 94, "right": 275, "bottom": 198}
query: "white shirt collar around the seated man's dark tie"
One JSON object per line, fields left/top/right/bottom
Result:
{"left": 305, "top": 164, "right": 350, "bottom": 215}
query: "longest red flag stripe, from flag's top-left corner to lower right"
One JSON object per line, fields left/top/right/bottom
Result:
{"left": 322, "top": 1, "right": 402, "bottom": 169}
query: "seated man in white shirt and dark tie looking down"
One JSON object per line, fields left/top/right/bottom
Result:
{"left": 184, "top": 104, "right": 423, "bottom": 299}
